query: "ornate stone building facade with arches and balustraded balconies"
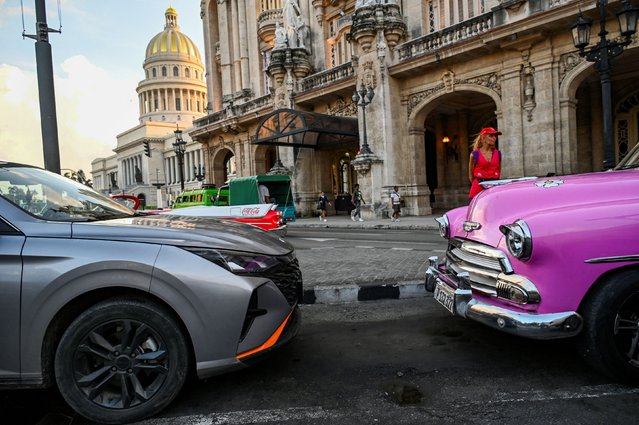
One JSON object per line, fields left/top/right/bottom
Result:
{"left": 190, "top": 0, "right": 639, "bottom": 218}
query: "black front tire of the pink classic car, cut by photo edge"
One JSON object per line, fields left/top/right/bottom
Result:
{"left": 577, "top": 270, "right": 639, "bottom": 385}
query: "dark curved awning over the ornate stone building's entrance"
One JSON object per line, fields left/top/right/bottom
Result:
{"left": 253, "top": 109, "right": 359, "bottom": 150}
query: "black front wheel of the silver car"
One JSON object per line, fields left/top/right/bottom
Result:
{"left": 55, "top": 298, "right": 189, "bottom": 424}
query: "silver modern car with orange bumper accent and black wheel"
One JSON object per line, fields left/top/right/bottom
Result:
{"left": 0, "top": 161, "right": 302, "bottom": 424}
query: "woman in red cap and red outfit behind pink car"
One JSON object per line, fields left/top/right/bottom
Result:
{"left": 468, "top": 127, "right": 501, "bottom": 199}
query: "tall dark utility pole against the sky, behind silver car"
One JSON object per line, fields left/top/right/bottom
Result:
{"left": 22, "top": 0, "right": 60, "bottom": 174}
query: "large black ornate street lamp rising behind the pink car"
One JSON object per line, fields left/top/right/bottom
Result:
{"left": 571, "top": 0, "right": 639, "bottom": 170}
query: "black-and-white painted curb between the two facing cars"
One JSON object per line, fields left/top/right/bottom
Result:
{"left": 302, "top": 281, "right": 429, "bottom": 304}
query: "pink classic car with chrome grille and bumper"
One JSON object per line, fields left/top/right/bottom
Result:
{"left": 426, "top": 148, "right": 639, "bottom": 384}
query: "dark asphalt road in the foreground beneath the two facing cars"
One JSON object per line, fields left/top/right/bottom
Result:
{"left": 11, "top": 298, "right": 639, "bottom": 425}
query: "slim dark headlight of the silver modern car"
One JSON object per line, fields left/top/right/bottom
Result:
{"left": 184, "top": 247, "right": 281, "bottom": 274}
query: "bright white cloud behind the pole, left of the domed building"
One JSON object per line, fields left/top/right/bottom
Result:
{"left": 0, "top": 55, "right": 139, "bottom": 174}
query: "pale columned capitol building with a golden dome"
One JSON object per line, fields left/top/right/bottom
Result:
{"left": 91, "top": 7, "right": 208, "bottom": 207}
